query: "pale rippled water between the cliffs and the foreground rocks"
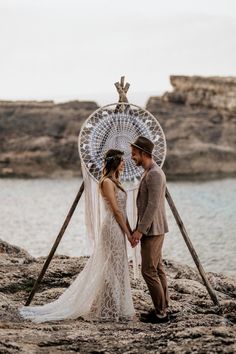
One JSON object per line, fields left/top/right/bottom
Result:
{"left": 0, "top": 179, "right": 236, "bottom": 275}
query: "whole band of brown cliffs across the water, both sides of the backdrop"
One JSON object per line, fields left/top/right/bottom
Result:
{"left": 0, "top": 76, "right": 236, "bottom": 180}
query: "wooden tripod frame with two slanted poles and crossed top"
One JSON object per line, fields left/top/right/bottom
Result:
{"left": 25, "top": 76, "right": 220, "bottom": 306}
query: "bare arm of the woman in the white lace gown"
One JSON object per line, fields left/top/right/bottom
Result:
{"left": 102, "top": 178, "right": 131, "bottom": 240}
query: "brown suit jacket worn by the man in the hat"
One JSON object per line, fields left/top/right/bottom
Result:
{"left": 137, "top": 163, "right": 168, "bottom": 236}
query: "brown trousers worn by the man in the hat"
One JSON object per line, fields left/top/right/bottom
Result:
{"left": 141, "top": 235, "right": 169, "bottom": 314}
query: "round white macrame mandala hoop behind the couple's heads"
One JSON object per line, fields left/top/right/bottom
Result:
{"left": 79, "top": 103, "right": 166, "bottom": 188}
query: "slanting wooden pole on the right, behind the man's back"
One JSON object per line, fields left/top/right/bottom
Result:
{"left": 166, "top": 188, "right": 220, "bottom": 306}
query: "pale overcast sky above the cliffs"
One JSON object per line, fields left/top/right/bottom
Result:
{"left": 0, "top": 0, "right": 236, "bottom": 105}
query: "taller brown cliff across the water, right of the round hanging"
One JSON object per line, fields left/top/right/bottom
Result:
{"left": 146, "top": 76, "right": 236, "bottom": 179}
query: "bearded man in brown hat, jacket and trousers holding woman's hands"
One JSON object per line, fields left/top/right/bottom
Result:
{"left": 131, "top": 136, "right": 169, "bottom": 323}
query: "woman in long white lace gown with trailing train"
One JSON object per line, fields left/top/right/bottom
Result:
{"left": 20, "top": 149, "right": 134, "bottom": 322}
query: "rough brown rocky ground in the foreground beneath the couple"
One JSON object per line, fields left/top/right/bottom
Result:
{"left": 0, "top": 241, "right": 236, "bottom": 354}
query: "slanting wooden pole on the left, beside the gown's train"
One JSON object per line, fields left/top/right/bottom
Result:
{"left": 25, "top": 182, "right": 84, "bottom": 306}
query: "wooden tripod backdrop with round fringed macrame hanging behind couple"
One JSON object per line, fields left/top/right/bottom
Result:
{"left": 26, "top": 77, "right": 219, "bottom": 306}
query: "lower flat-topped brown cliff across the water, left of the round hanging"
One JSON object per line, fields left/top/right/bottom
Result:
{"left": 0, "top": 101, "right": 98, "bottom": 177}
